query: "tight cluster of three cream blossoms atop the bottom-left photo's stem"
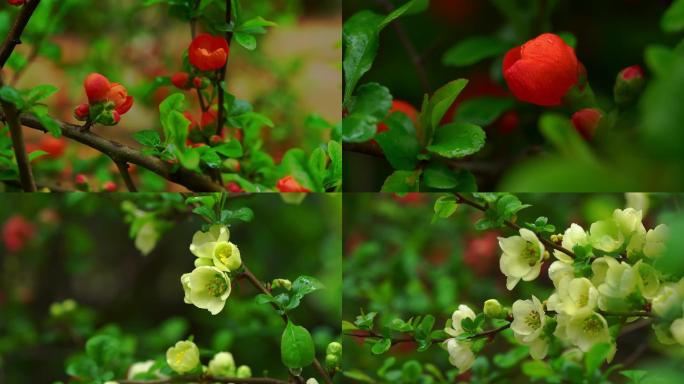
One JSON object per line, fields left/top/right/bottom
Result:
{"left": 181, "top": 225, "right": 242, "bottom": 315}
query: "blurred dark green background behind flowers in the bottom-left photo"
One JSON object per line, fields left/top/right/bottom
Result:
{"left": 0, "top": 193, "right": 342, "bottom": 383}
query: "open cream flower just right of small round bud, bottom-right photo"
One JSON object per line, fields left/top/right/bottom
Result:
{"left": 511, "top": 296, "right": 549, "bottom": 360}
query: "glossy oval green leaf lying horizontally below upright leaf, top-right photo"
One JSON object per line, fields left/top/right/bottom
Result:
{"left": 427, "top": 123, "right": 486, "bottom": 158}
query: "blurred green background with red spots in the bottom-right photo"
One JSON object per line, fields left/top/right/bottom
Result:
{"left": 343, "top": 194, "right": 684, "bottom": 383}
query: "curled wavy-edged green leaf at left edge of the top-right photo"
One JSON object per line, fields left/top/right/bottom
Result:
{"left": 342, "top": 83, "right": 392, "bottom": 143}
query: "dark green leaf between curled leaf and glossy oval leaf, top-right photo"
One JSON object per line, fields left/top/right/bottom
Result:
{"left": 375, "top": 112, "right": 420, "bottom": 170}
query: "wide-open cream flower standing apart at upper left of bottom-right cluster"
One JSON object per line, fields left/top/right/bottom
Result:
{"left": 499, "top": 228, "right": 545, "bottom": 290}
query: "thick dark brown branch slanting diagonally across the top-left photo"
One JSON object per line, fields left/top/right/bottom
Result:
{"left": 0, "top": 111, "right": 225, "bottom": 192}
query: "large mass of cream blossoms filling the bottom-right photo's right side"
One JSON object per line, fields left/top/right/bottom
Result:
{"left": 445, "top": 208, "right": 684, "bottom": 372}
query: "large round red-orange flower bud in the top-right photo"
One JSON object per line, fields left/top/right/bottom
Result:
{"left": 503, "top": 33, "right": 580, "bottom": 107}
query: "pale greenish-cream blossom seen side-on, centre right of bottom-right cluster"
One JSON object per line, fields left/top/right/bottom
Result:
{"left": 594, "top": 258, "right": 639, "bottom": 311}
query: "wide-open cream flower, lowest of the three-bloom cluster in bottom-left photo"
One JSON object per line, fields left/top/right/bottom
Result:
{"left": 181, "top": 267, "right": 231, "bottom": 315}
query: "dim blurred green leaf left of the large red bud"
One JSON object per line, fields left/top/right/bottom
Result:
{"left": 442, "top": 36, "right": 511, "bottom": 67}
